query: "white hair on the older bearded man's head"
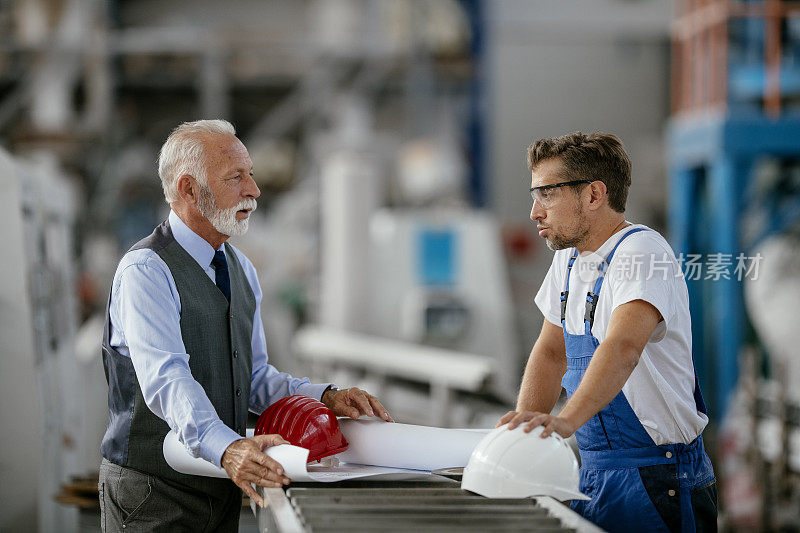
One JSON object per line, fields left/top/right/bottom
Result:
{"left": 158, "top": 119, "right": 236, "bottom": 203}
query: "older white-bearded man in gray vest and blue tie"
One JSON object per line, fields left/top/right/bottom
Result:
{"left": 99, "top": 120, "right": 391, "bottom": 531}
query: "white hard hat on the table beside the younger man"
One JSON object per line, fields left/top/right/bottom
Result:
{"left": 461, "top": 424, "right": 591, "bottom": 501}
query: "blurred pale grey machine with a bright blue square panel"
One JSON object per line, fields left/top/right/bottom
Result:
{"left": 370, "top": 208, "right": 520, "bottom": 404}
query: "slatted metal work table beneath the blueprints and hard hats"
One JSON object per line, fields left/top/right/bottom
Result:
{"left": 254, "top": 476, "right": 601, "bottom": 533}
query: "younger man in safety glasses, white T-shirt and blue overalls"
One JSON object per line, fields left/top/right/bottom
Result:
{"left": 498, "top": 133, "right": 717, "bottom": 531}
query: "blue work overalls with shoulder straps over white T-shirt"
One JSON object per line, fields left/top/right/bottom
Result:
{"left": 561, "top": 228, "right": 714, "bottom": 532}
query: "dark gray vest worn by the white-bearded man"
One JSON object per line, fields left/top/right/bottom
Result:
{"left": 100, "top": 221, "right": 256, "bottom": 495}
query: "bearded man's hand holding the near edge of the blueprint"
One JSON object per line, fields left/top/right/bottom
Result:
{"left": 222, "top": 435, "right": 290, "bottom": 507}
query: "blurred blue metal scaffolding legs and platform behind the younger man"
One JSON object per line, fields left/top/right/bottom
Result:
{"left": 668, "top": 115, "right": 800, "bottom": 420}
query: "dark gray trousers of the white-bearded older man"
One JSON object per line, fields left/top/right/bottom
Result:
{"left": 98, "top": 459, "right": 242, "bottom": 532}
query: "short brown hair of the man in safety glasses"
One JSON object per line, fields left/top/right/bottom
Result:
{"left": 528, "top": 131, "right": 631, "bottom": 213}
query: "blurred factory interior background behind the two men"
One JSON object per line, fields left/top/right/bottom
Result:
{"left": 0, "top": 0, "right": 800, "bottom": 532}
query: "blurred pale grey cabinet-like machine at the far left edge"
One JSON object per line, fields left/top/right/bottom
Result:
{"left": 0, "top": 149, "right": 85, "bottom": 531}
